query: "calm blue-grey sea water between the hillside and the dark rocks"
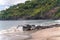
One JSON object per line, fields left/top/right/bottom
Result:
{"left": 0, "top": 20, "right": 60, "bottom": 30}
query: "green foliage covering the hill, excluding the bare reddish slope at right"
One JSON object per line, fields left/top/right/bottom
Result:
{"left": 0, "top": 0, "right": 60, "bottom": 20}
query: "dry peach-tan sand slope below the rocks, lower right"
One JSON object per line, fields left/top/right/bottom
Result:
{"left": 30, "top": 27, "right": 60, "bottom": 40}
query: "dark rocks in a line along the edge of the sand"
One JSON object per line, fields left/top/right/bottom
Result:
{"left": 22, "top": 24, "right": 60, "bottom": 31}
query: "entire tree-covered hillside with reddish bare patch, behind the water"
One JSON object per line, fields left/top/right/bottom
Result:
{"left": 0, "top": 0, "right": 60, "bottom": 20}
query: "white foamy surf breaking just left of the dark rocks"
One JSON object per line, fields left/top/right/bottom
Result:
{"left": 0, "top": 27, "right": 23, "bottom": 34}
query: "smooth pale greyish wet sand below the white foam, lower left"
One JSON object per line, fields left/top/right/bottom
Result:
{"left": 0, "top": 34, "right": 29, "bottom": 40}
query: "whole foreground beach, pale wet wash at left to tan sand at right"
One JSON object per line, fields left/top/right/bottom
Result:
{"left": 0, "top": 26, "right": 60, "bottom": 40}
